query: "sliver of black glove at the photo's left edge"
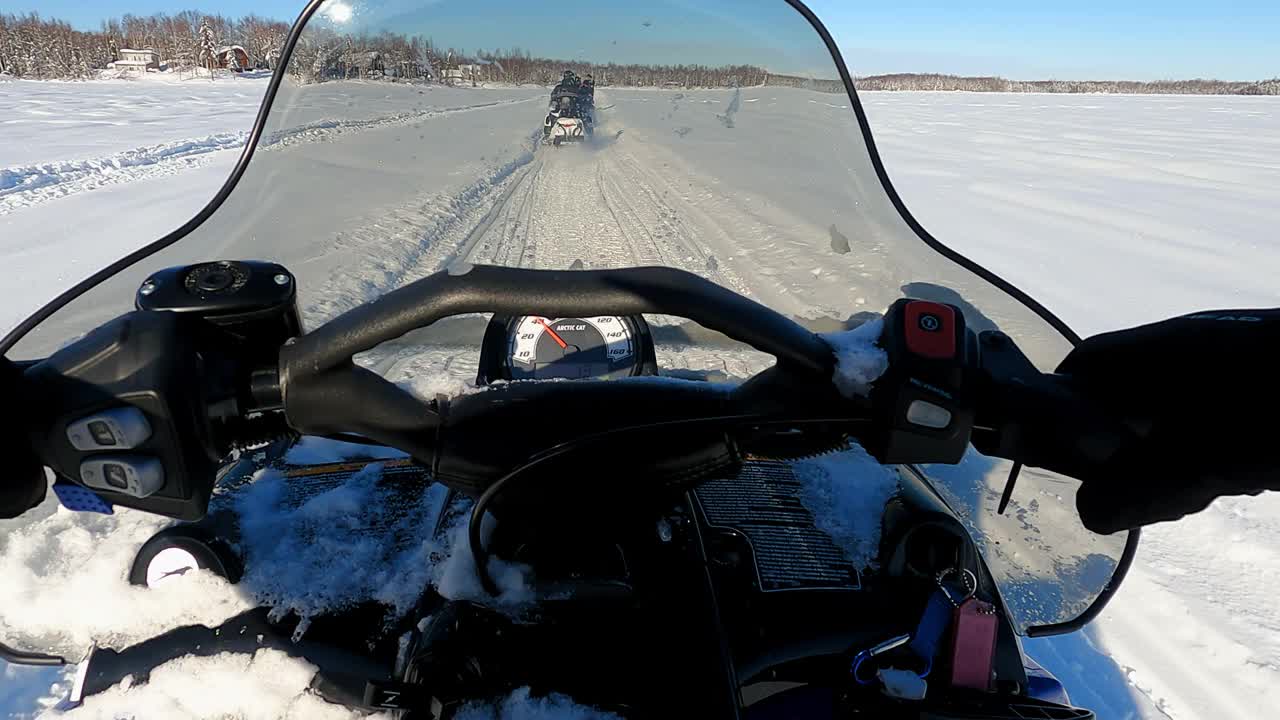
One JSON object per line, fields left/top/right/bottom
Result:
{"left": 0, "top": 357, "right": 47, "bottom": 519}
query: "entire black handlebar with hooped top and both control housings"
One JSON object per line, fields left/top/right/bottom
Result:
{"left": 10, "top": 263, "right": 1141, "bottom": 530}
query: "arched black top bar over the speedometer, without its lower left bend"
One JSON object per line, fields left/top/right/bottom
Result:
{"left": 282, "top": 265, "right": 835, "bottom": 377}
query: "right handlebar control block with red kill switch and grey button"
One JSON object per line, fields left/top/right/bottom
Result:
{"left": 865, "top": 300, "right": 978, "bottom": 464}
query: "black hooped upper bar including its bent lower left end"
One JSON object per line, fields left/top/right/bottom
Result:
{"left": 279, "top": 265, "right": 835, "bottom": 471}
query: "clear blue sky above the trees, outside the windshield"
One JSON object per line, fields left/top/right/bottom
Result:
{"left": 0, "top": 0, "right": 1280, "bottom": 79}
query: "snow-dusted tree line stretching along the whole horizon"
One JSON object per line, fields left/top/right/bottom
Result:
{"left": 0, "top": 10, "right": 1280, "bottom": 95}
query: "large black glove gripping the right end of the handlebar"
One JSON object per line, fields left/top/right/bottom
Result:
{"left": 1057, "top": 310, "right": 1280, "bottom": 533}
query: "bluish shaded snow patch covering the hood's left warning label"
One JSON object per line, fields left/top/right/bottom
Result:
{"left": 234, "top": 462, "right": 532, "bottom": 637}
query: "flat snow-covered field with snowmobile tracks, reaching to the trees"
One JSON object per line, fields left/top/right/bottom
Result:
{"left": 0, "top": 78, "right": 1280, "bottom": 720}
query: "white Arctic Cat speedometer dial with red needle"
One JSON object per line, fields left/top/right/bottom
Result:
{"left": 508, "top": 315, "right": 636, "bottom": 379}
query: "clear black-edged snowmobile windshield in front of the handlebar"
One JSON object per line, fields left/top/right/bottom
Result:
{"left": 9, "top": 0, "right": 1126, "bottom": 630}
